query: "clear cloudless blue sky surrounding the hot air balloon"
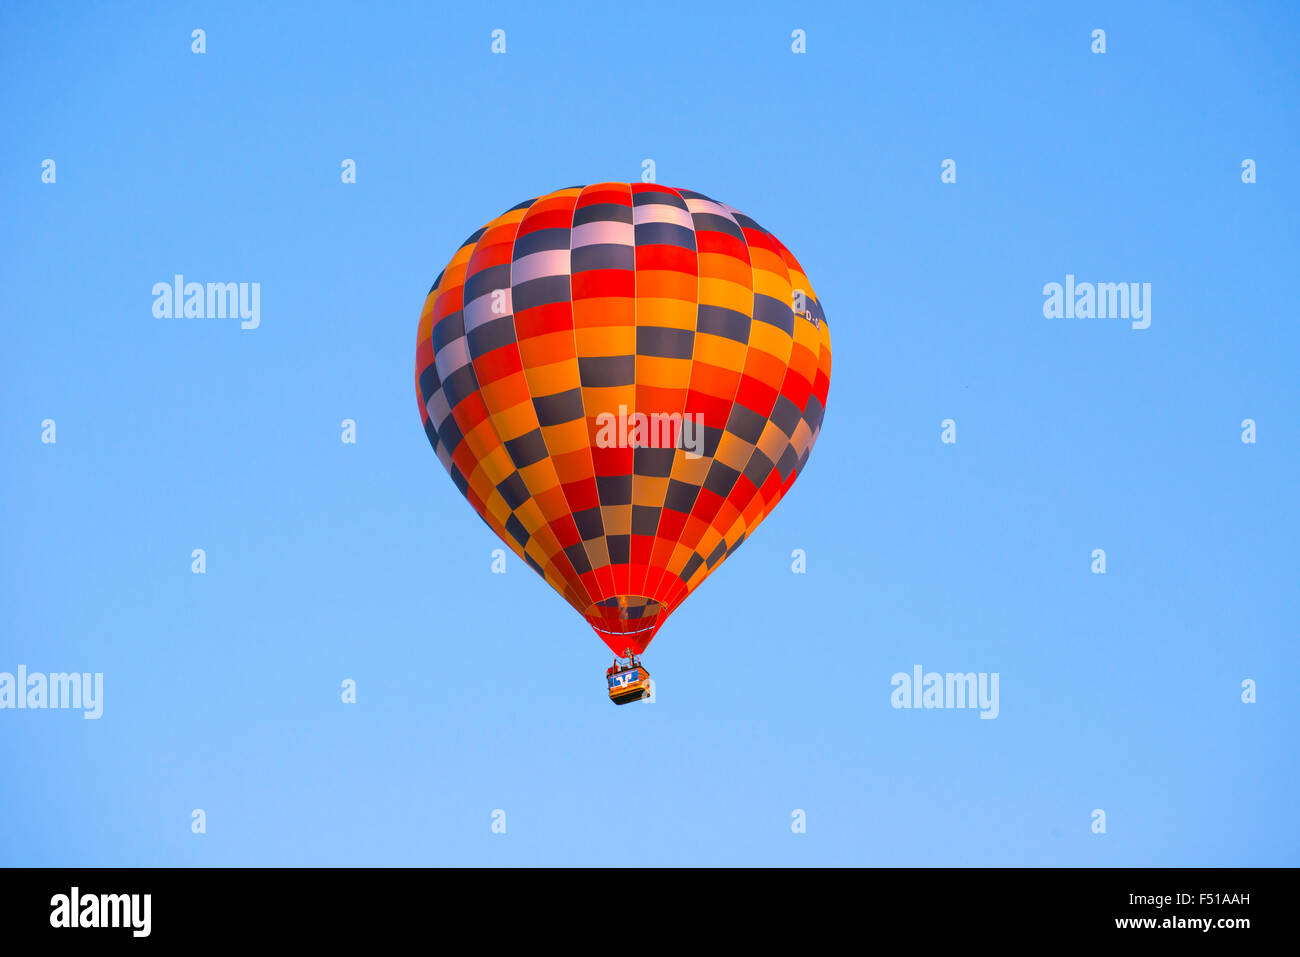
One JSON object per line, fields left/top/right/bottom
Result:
{"left": 0, "top": 3, "right": 1300, "bottom": 865}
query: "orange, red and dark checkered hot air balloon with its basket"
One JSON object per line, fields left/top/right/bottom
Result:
{"left": 415, "top": 183, "right": 831, "bottom": 703}
